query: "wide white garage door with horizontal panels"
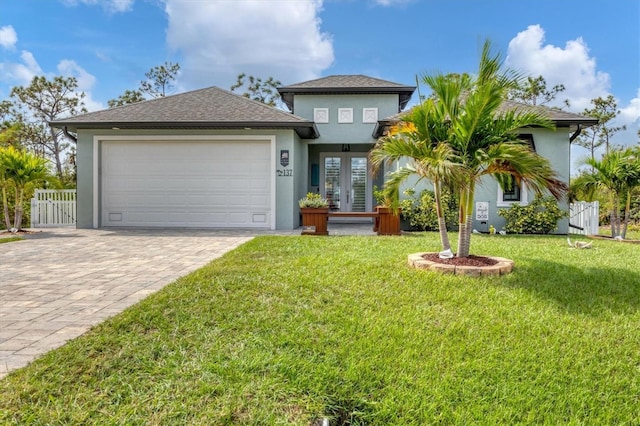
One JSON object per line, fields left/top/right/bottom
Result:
{"left": 101, "top": 140, "right": 274, "bottom": 228}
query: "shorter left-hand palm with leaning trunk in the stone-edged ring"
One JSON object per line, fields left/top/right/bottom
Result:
{"left": 370, "top": 99, "right": 460, "bottom": 257}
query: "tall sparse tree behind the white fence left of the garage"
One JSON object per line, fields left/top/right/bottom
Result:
{"left": 11, "top": 76, "right": 87, "bottom": 181}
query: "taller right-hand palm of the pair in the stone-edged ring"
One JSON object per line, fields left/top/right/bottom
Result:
{"left": 423, "top": 41, "right": 567, "bottom": 257}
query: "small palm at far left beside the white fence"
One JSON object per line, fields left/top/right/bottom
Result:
{"left": 0, "top": 147, "right": 48, "bottom": 231}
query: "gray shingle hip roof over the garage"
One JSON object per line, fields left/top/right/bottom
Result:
{"left": 50, "top": 87, "right": 318, "bottom": 138}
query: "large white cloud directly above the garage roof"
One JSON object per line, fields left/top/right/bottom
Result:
{"left": 165, "top": 0, "right": 334, "bottom": 89}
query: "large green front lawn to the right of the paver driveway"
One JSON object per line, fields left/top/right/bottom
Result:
{"left": 0, "top": 234, "right": 640, "bottom": 425}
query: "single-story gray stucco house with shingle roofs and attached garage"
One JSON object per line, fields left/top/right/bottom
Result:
{"left": 50, "top": 75, "right": 594, "bottom": 232}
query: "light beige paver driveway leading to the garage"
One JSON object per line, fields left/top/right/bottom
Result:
{"left": 0, "top": 229, "right": 262, "bottom": 378}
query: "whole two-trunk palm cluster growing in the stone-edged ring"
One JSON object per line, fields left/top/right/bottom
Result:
{"left": 372, "top": 41, "right": 567, "bottom": 257}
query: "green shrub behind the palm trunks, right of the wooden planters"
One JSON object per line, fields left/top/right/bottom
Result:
{"left": 400, "top": 189, "right": 458, "bottom": 231}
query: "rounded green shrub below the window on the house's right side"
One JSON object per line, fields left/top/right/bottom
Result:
{"left": 498, "top": 197, "right": 568, "bottom": 234}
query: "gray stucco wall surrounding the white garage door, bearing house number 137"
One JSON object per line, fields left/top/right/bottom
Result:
{"left": 77, "top": 129, "right": 306, "bottom": 229}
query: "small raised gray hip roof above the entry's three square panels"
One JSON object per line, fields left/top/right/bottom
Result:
{"left": 278, "top": 75, "right": 416, "bottom": 111}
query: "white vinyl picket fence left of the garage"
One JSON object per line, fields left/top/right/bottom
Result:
{"left": 31, "top": 189, "right": 76, "bottom": 228}
